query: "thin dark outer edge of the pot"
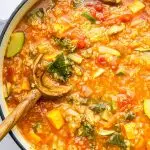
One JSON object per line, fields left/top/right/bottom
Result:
{"left": 0, "top": 0, "right": 28, "bottom": 150}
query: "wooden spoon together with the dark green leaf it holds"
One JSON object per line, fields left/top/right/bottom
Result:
{"left": 0, "top": 48, "right": 71, "bottom": 140}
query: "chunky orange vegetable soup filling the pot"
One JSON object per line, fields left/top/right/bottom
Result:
{"left": 3, "top": 0, "right": 150, "bottom": 150}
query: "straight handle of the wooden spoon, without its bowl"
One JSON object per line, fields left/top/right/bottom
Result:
{"left": 0, "top": 89, "right": 42, "bottom": 141}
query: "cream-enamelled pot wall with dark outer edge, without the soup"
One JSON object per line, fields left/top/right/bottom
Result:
{"left": 0, "top": 0, "right": 38, "bottom": 150}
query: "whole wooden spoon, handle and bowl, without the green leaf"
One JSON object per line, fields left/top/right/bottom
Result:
{"left": 0, "top": 55, "right": 71, "bottom": 141}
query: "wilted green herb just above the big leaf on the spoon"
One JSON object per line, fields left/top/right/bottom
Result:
{"left": 54, "top": 37, "right": 76, "bottom": 53}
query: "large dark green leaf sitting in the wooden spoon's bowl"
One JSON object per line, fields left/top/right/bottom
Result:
{"left": 47, "top": 54, "right": 72, "bottom": 82}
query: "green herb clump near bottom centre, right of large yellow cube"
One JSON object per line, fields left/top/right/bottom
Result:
{"left": 77, "top": 122, "right": 95, "bottom": 140}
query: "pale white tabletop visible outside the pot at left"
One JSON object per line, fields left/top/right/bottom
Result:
{"left": 0, "top": 0, "right": 21, "bottom": 150}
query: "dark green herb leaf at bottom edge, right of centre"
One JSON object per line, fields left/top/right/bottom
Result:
{"left": 107, "top": 132, "right": 127, "bottom": 150}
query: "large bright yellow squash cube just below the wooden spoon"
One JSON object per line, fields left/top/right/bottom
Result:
{"left": 47, "top": 109, "right": 64, "bottom": 130}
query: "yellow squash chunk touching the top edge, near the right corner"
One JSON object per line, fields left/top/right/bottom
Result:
{"left": 129, "top": 0, "right": 145, "bottom": 13}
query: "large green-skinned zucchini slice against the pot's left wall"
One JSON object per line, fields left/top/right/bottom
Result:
{"left": 6, "top": 32, "right": 25, "bottom": 58}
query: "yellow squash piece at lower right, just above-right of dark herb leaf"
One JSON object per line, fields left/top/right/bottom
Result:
{"left": 124, "top": 122, "right": 136, "bottom": 140}
